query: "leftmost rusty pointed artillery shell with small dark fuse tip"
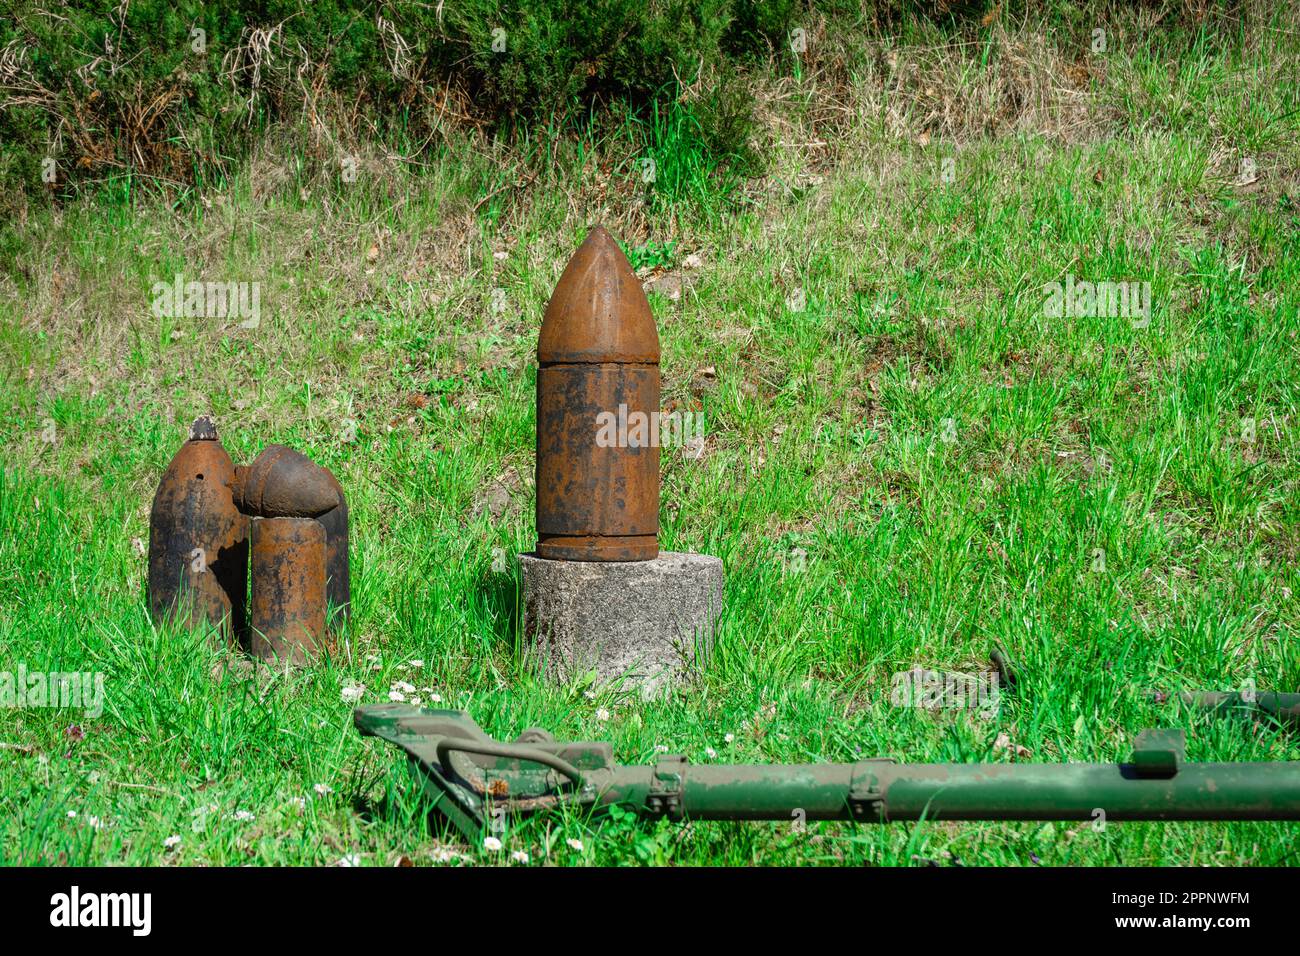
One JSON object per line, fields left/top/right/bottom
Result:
{"left": 148, "top": 416, "right": 248, "bottom": 636}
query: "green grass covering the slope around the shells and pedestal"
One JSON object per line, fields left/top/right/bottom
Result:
{"left": 0, "top": 14, "right": 1300, "bottom": 865}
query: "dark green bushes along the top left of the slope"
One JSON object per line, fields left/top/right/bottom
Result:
{"left": 0, "top": 0, "right": 796, "bottom": 209}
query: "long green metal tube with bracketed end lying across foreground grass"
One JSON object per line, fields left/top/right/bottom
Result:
{"left": 354, "top": 704, "right": 1300, "bottom": 839}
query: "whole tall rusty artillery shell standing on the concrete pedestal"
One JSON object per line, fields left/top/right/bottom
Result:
{"left": 537, "top": 226, "right": 659, "bottom": 561}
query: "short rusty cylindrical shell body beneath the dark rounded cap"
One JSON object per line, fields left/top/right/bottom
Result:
{"left": 250, "top": 518, "right": 325, "bottom": 663}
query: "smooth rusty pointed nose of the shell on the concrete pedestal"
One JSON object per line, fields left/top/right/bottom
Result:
{"left": 537, "top": 226, "right": 659, "bottom": 365}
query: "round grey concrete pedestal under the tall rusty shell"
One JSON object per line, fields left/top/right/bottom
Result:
{"left": 519, "top": 551, "right": 723, "bottom": 698}
